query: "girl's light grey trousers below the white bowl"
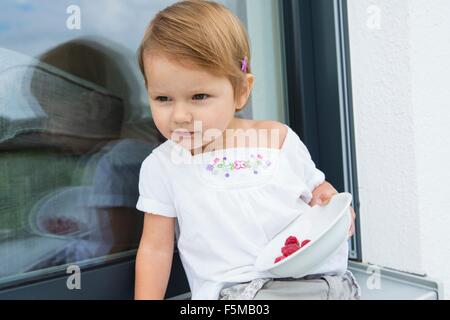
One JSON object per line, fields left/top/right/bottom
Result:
{"left": 219, "top": 270, "right": 361, "bottom": 300}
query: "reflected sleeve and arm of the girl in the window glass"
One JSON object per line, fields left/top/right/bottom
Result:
{"left": 86, "top": 139, "right": 155, "bottom": 256}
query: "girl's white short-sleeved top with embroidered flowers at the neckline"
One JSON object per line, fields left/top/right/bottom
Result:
{"left": 136, "top": 125, "right": 348, "bottom": 300}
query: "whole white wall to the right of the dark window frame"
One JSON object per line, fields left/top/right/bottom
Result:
{"left": 348, "top": 0, "right": 450, "bottom": 299}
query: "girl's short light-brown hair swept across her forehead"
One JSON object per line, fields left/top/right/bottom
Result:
{"left": 138, "top": 0, "right": 251, "bottom": 105}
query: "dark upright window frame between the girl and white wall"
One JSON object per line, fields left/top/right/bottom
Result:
{"left": 282, "top": 0, "right": 361, "bottom": 261}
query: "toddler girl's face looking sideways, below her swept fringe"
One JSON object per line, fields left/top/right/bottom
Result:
{"left": 144, "top": 54, "right": 248, "bottom": 151}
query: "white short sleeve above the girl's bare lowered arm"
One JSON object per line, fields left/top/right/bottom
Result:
{"left": 136, "top": 153, "right": 176, "bottom": 218}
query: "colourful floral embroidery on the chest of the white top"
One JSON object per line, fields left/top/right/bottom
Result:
{"left": 206, "top": 154, "right": 272, "bottom": 178}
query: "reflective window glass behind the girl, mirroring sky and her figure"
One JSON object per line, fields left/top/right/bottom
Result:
{"left": 0, "top": 0, "right": 286, "bottom": 288}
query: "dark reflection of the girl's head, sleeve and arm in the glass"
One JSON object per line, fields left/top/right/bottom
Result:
{"left": 26, "top": 39, "right": 160, "bottom": 263}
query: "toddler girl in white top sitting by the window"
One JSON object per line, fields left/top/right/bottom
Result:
{"left": 135, "top": 1, "right": 359, "bottom": 299}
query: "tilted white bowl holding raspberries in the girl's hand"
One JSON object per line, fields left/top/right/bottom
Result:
{"left": 255, "top": 192, "right": 352, "bottom": 278}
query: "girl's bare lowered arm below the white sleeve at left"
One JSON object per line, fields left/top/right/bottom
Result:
{"left": 134, "top": 213, "right": 175, "bottom": 300}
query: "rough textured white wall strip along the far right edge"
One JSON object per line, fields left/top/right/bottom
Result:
{"left": 410, "top": 0, "right": 450, "bottom": 299}
